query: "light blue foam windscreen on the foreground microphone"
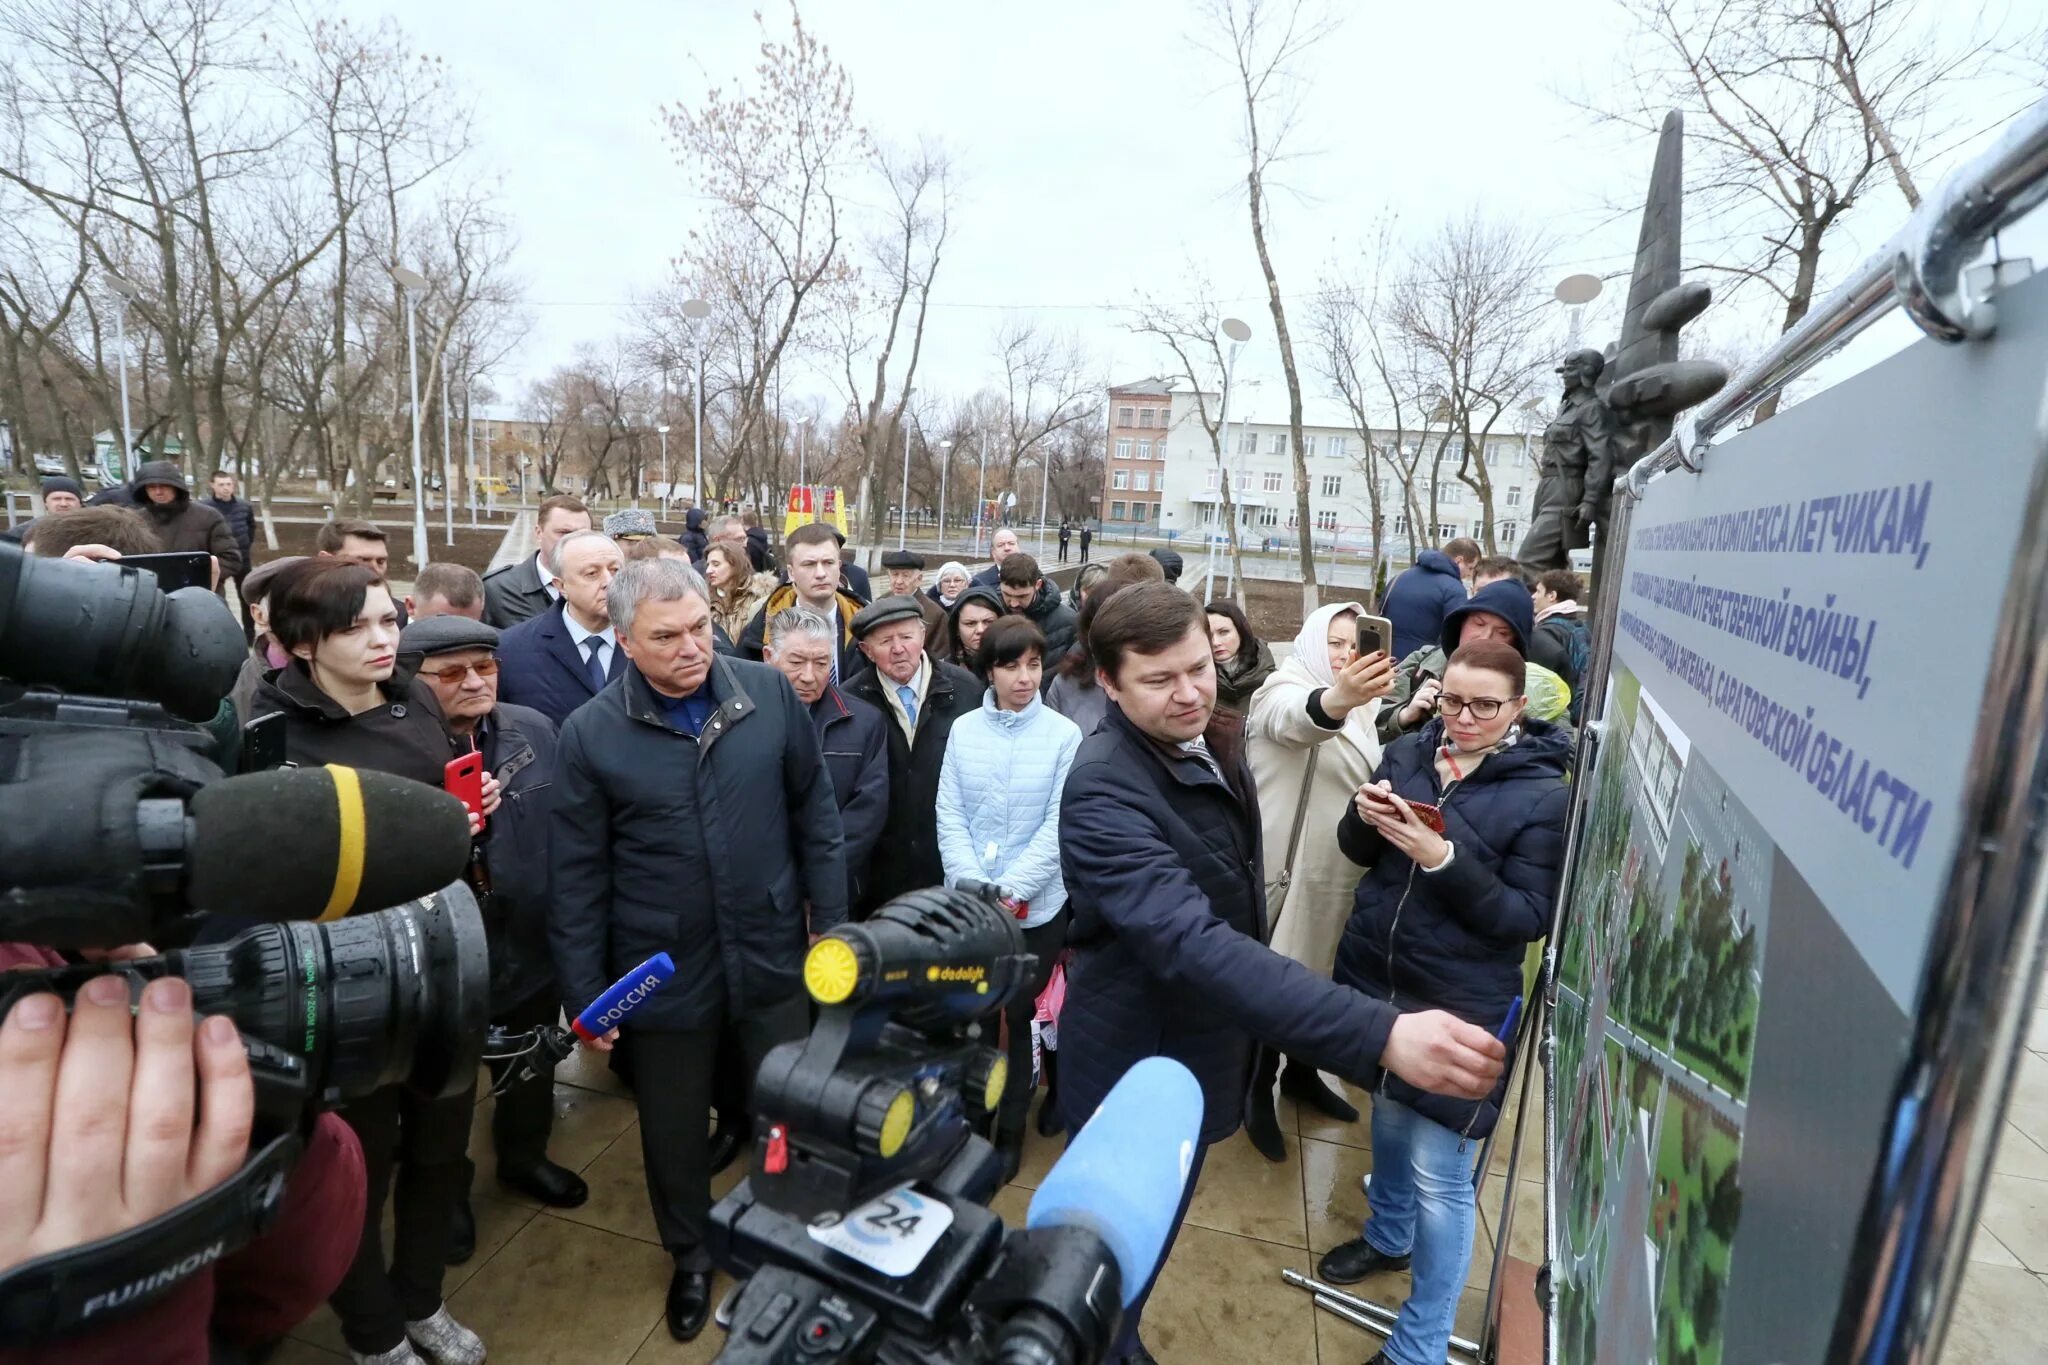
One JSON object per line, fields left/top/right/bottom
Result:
{"left": 1024, "top": 1056, "right": 1202, "bottom": 1308}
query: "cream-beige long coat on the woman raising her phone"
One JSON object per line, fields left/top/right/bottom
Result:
{"left": 1245, "top": 613, "right": 1380, "bottom": 974}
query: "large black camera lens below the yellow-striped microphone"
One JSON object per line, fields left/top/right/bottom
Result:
{"left": 178, "top": 884, "right": 489, "bottom": 1105}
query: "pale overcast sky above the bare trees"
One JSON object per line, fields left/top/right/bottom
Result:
{"left": 342, "top": 0, "right": 2048, "bottom": 421}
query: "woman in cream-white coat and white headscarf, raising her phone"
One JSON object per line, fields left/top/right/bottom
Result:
{"left": 1245, "top": 602, "right": 1395, "bottom": 1160}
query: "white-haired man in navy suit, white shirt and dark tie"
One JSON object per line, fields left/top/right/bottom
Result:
{"left": 498, "top": 530, "right": 627, "bottom": 726}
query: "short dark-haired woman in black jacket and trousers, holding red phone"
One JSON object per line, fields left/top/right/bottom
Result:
{"left": 254, "top": 559, "right": 496, "bottom": 1365}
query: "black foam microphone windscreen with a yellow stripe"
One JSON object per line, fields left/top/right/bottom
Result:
{"left": 186, "top": 765, "right": 469, "bottom": 919}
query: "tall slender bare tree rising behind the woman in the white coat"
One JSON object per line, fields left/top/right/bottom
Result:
{"left": 1206, "top": 0, "right": 1335, "bottom": 612}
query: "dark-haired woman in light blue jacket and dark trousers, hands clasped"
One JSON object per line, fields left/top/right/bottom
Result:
{"left": 938, "top": 616, "right": 1081, "bottom": 1181}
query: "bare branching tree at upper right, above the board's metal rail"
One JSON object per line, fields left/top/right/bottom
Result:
{"left": 1602, "top": 0, "right": 2032, "bottom": 420}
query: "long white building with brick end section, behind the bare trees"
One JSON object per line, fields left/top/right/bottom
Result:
{"left": 1100, "top": 379, "right": 1540, "bottom": 563}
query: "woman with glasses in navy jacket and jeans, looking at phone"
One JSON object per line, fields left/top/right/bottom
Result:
{"left": 1317, "top": 641, "right": 1571, "bottom": 1365}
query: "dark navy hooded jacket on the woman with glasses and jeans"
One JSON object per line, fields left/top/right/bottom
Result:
{"left": 1333, "top": 718, "right": 1571, "bottom": 1138}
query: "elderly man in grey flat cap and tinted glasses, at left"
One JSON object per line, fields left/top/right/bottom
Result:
{"left": 397, "top": 614, "right": 590, "bottom": 1265}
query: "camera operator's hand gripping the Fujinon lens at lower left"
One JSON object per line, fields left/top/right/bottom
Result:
{"left": 0, "top": 976, "right": 256, "bottom": 1269}
